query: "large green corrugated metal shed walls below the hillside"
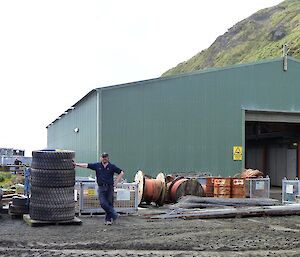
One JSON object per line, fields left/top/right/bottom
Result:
{"left": 47, "top": 57, "right": 300, "bottom": 180}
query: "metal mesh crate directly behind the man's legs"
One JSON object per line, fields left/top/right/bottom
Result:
{"left": 76, "top": 182, "right": 138, "bottom": 215}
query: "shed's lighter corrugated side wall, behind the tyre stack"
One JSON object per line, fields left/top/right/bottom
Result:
{"left": 48, "top": 91, "right": 98, "bottom": 176}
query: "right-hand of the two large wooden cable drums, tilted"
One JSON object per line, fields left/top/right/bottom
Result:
{"left": 169, "top": 178, "right": 203, "bottom": 203}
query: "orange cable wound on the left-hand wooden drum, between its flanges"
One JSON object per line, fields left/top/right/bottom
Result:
{"left": 143, "top": 177, "right": 163, "bottom": 203}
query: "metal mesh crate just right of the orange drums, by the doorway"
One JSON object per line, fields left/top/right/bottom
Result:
{"left": 246, "top": 176, "right": 270, "bottom": 198}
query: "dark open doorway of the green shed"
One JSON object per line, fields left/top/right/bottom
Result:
{"left": 245, "top": 112, "right": 300, "bottom": 186}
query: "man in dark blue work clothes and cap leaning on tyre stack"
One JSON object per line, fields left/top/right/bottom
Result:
{"left": 75, "top": 153, "right": 124, "bottom": 225}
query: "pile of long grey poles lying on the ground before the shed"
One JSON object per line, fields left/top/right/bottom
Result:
{"left": 147, "top": 196, "right": 300, "bottom": 219}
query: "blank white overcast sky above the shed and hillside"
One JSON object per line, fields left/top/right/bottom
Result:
{"left": 0, "top": 0, "right": 281, "bottom": 156}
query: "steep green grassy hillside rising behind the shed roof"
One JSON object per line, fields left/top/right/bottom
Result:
{"left": 162, "top": 0, "right": 300, "bottom": 76}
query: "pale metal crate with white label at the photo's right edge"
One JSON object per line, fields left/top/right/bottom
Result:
{"left": 282, "top": 178, "right": 300, "bottom": 204}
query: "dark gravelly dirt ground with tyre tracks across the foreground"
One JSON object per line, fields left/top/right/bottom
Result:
{"left": 0, "top": 207, "right": 300, "bottom": 257}
